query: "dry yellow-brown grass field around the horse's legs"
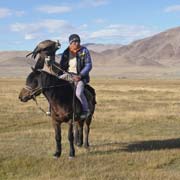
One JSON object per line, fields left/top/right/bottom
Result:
{"left": 0, "top": 78, "right": 180, "bottom": 180}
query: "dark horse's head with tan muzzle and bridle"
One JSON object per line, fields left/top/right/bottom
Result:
{"left": 19, "top": 68, "right": 42, "bottom": 102}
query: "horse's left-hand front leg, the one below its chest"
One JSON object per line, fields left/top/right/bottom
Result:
{"left": 53, "top": 123, "right": 61, "bottom": 158}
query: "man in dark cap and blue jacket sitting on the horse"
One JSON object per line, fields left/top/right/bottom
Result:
{"left": 60, "top": 34, "right": 92, "bottom": 119}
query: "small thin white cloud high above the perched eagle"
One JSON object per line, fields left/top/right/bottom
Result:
{"left": 37, "top": 5, "right": 72, "bottom": 14}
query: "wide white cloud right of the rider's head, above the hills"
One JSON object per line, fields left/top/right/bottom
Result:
{"left": 89, "top": 24, "right": 157, "bottom": 44}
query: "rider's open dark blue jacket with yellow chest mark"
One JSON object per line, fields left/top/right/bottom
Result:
{"left": 60, "top": 46, "right": 92, "bottom": 83}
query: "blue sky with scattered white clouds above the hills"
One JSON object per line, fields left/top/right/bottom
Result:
{"left": 0, "top": 0, "right": 180, "bottom": 52}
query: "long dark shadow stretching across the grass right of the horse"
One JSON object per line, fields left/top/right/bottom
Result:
{"left": 90, "top": 138, "right": 180, "bottom": 155}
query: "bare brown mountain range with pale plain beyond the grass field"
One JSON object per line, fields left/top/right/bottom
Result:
{"left": 0, "top": 27, "right": 180, "bottom": 77}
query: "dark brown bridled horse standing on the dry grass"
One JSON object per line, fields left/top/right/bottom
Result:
{"left": 19, "top": 70, "right": 96, "bottom": 158}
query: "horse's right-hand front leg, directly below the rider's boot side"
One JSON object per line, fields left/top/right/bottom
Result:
{"left": 68, "top": 121, "right": 75, "bottom": 157}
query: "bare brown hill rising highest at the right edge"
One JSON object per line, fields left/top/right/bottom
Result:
{"left": 104, "top": 27, "right": 180, "bottom": 67}
